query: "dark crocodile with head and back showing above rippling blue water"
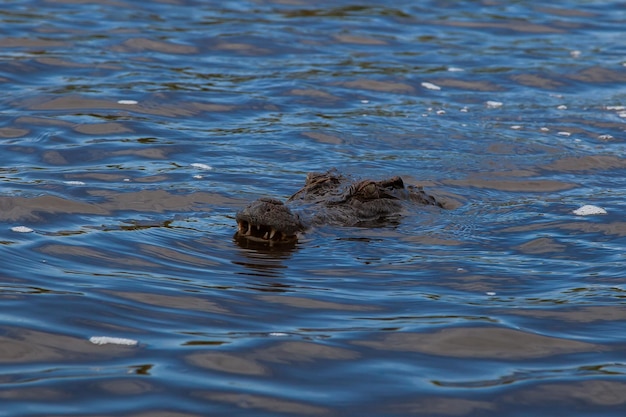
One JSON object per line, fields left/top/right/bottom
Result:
{"left": 235, "top": 169, "right": 446, "bottom": 244}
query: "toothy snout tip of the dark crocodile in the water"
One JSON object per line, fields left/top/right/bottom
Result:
{"left": 236, "top": 198, "right": 304, "bottom": 242}
